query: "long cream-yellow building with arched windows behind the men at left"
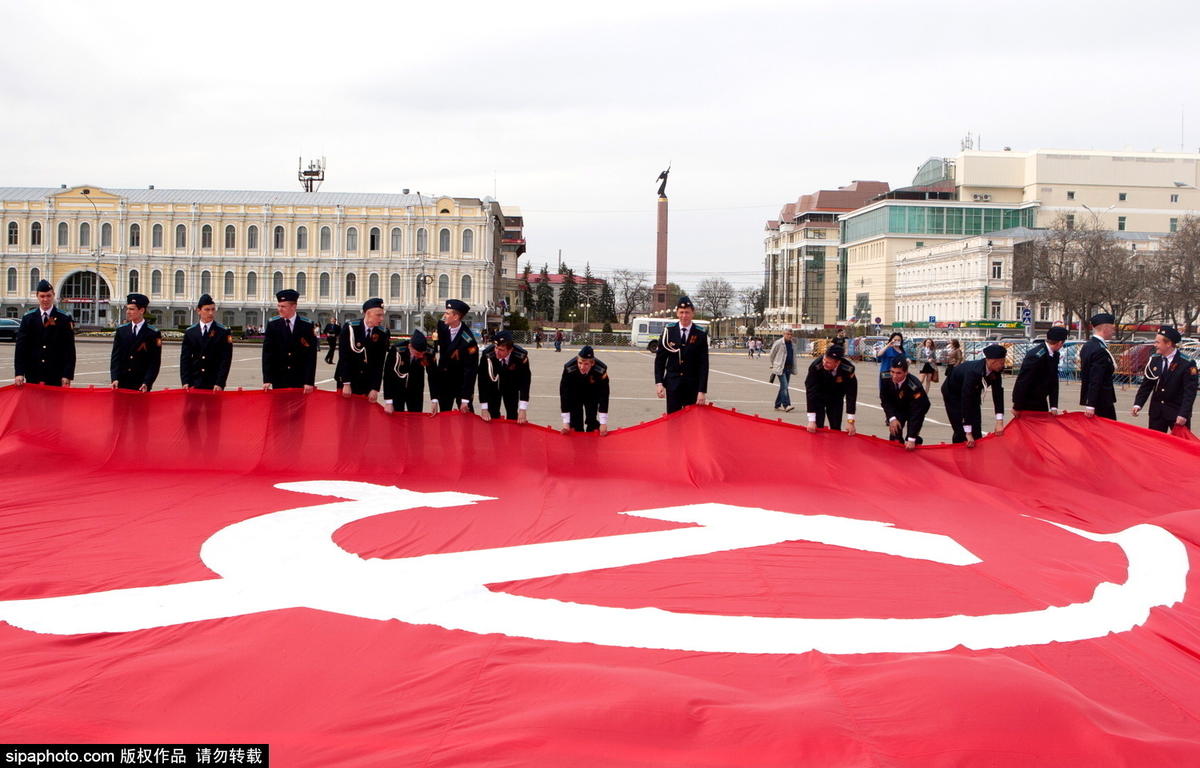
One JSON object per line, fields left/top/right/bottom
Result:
{"left": 0, "top": 186, "right": 515, "bottom": 331}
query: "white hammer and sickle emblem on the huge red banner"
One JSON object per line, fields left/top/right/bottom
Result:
{"left": 0, "top": 481, "right": 1188, "bottom": 653}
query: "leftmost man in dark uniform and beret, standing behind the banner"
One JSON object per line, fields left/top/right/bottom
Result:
{"left": 13, "top": 280, "right": 74, "bottom": 386}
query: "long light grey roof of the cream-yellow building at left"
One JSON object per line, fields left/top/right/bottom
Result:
{"left": 0, "top": 186, "right": 458, "bottom": 208}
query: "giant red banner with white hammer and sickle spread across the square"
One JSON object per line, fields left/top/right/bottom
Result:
{"left": 0, "top": 385, "right": 1200, "bottom": 767}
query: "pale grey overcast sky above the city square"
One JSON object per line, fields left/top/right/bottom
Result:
{"left": 0, "top": 0, "right": 1200, "bottom": 294}
